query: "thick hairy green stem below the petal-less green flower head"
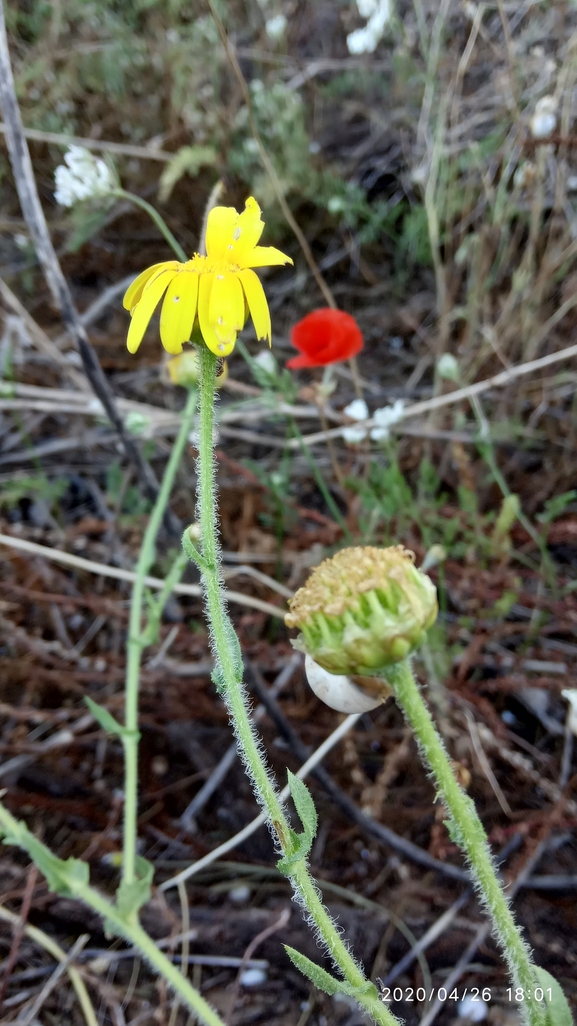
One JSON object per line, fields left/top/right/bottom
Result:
{"left": 384, "top": 660, "right": 547, "bottom": 1026}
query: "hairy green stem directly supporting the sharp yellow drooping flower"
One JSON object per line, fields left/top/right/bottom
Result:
{"left": 185, "top": 348, "right": 397, "bottom": 1026}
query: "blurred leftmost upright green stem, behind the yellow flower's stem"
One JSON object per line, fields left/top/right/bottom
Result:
{"left": 122, "top": 389, "right": 197, "bottom": 883}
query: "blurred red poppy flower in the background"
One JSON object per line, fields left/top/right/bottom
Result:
{"left": 286, "top": 307, "right": 364, "bottom": 368}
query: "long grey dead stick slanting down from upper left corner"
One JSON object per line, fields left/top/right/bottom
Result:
{"left": 0, "top": 3, "right": 175, "bottom": 521}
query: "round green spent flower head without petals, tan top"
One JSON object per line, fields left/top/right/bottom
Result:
{"left": 284, "top": 545, "right": 438, "bottom": 676}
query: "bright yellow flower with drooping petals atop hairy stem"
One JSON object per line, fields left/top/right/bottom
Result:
{"left": 123, "top": 196, "right": 293, "bottom": 356}
